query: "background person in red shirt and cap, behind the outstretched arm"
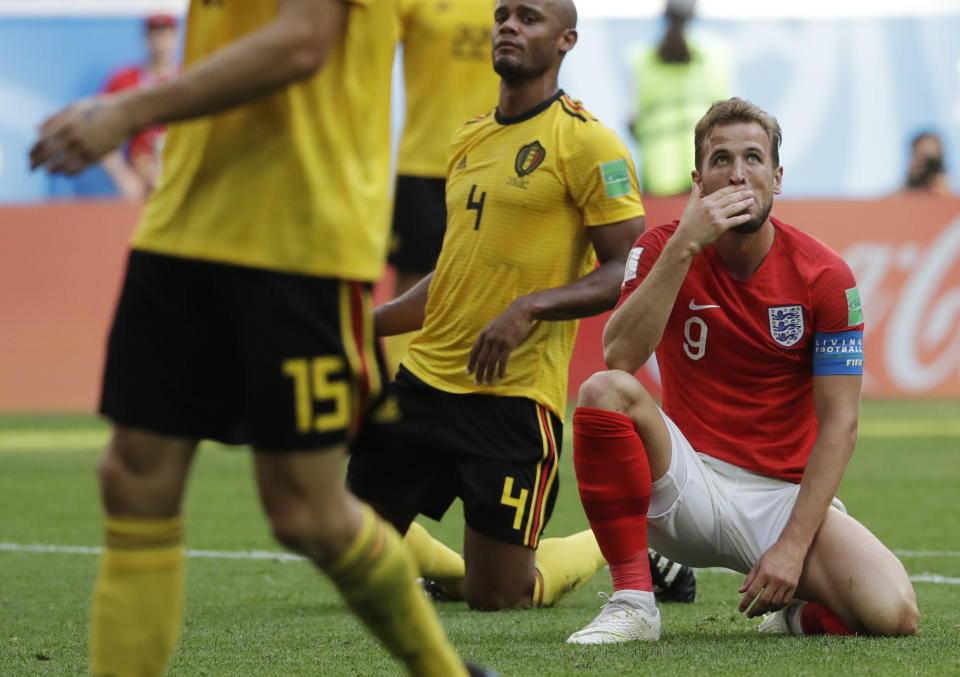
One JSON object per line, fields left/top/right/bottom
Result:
{"left": 103, "top": 14, "right": 179, "bottom": 200}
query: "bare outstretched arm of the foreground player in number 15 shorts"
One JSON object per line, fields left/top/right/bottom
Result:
{"left": 30, "top": 0, "right": 349, "bottom": 174}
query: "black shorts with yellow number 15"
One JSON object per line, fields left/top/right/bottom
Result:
{"left": 100, "top": 251, "right": 384, "bottom": 452}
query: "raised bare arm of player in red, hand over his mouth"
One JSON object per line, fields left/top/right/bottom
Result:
{"left": 603, "top": 182, "right": 753, "bottom": 374}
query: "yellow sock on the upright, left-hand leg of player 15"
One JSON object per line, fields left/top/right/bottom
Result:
{"left": 90, "top": 516, "right": 184, "bottom": 677}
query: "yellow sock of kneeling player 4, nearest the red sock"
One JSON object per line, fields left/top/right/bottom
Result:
{"left": 533, "top": 529, "right": 607, "bottom": 606}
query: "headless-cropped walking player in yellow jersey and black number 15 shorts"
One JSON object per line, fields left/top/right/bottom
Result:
{"left": 31, "top": 0, "right": 496, "bottom": 677}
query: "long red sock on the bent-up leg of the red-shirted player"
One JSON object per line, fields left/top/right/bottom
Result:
{"left": 573, "top": 407, "right": 653, "bottom": 592}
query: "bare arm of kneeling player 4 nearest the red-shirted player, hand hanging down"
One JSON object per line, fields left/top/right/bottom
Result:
{"left": 467, "top": 216, "right": 644, "bottom": 384}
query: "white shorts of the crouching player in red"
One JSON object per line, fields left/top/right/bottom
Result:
{"left": 647, "top": 404, "right": 846, "bottom": 574}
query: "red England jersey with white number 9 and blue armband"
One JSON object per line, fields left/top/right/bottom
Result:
{"left": 620, "top": 219, "right": 863, "bottom": 482}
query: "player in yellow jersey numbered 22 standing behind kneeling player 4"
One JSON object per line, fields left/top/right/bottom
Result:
{"left": 386, "top": 0, "right": 500, "bottom": 371}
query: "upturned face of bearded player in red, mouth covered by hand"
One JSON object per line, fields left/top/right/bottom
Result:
{"left": 693, "top": 122, "right": 783, "bottom": 233}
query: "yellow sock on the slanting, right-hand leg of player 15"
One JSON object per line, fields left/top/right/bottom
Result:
{"left": 327, "top": 505, "right": 467, "bottom": 677}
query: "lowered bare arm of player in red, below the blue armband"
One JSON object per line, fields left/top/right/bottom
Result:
{"left": 739, "top": 374, "right": 863, "bottom": 618}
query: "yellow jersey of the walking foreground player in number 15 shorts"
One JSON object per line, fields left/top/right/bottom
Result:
{"left": 133, "top": 0, "right": 399, "bottom": 281}
